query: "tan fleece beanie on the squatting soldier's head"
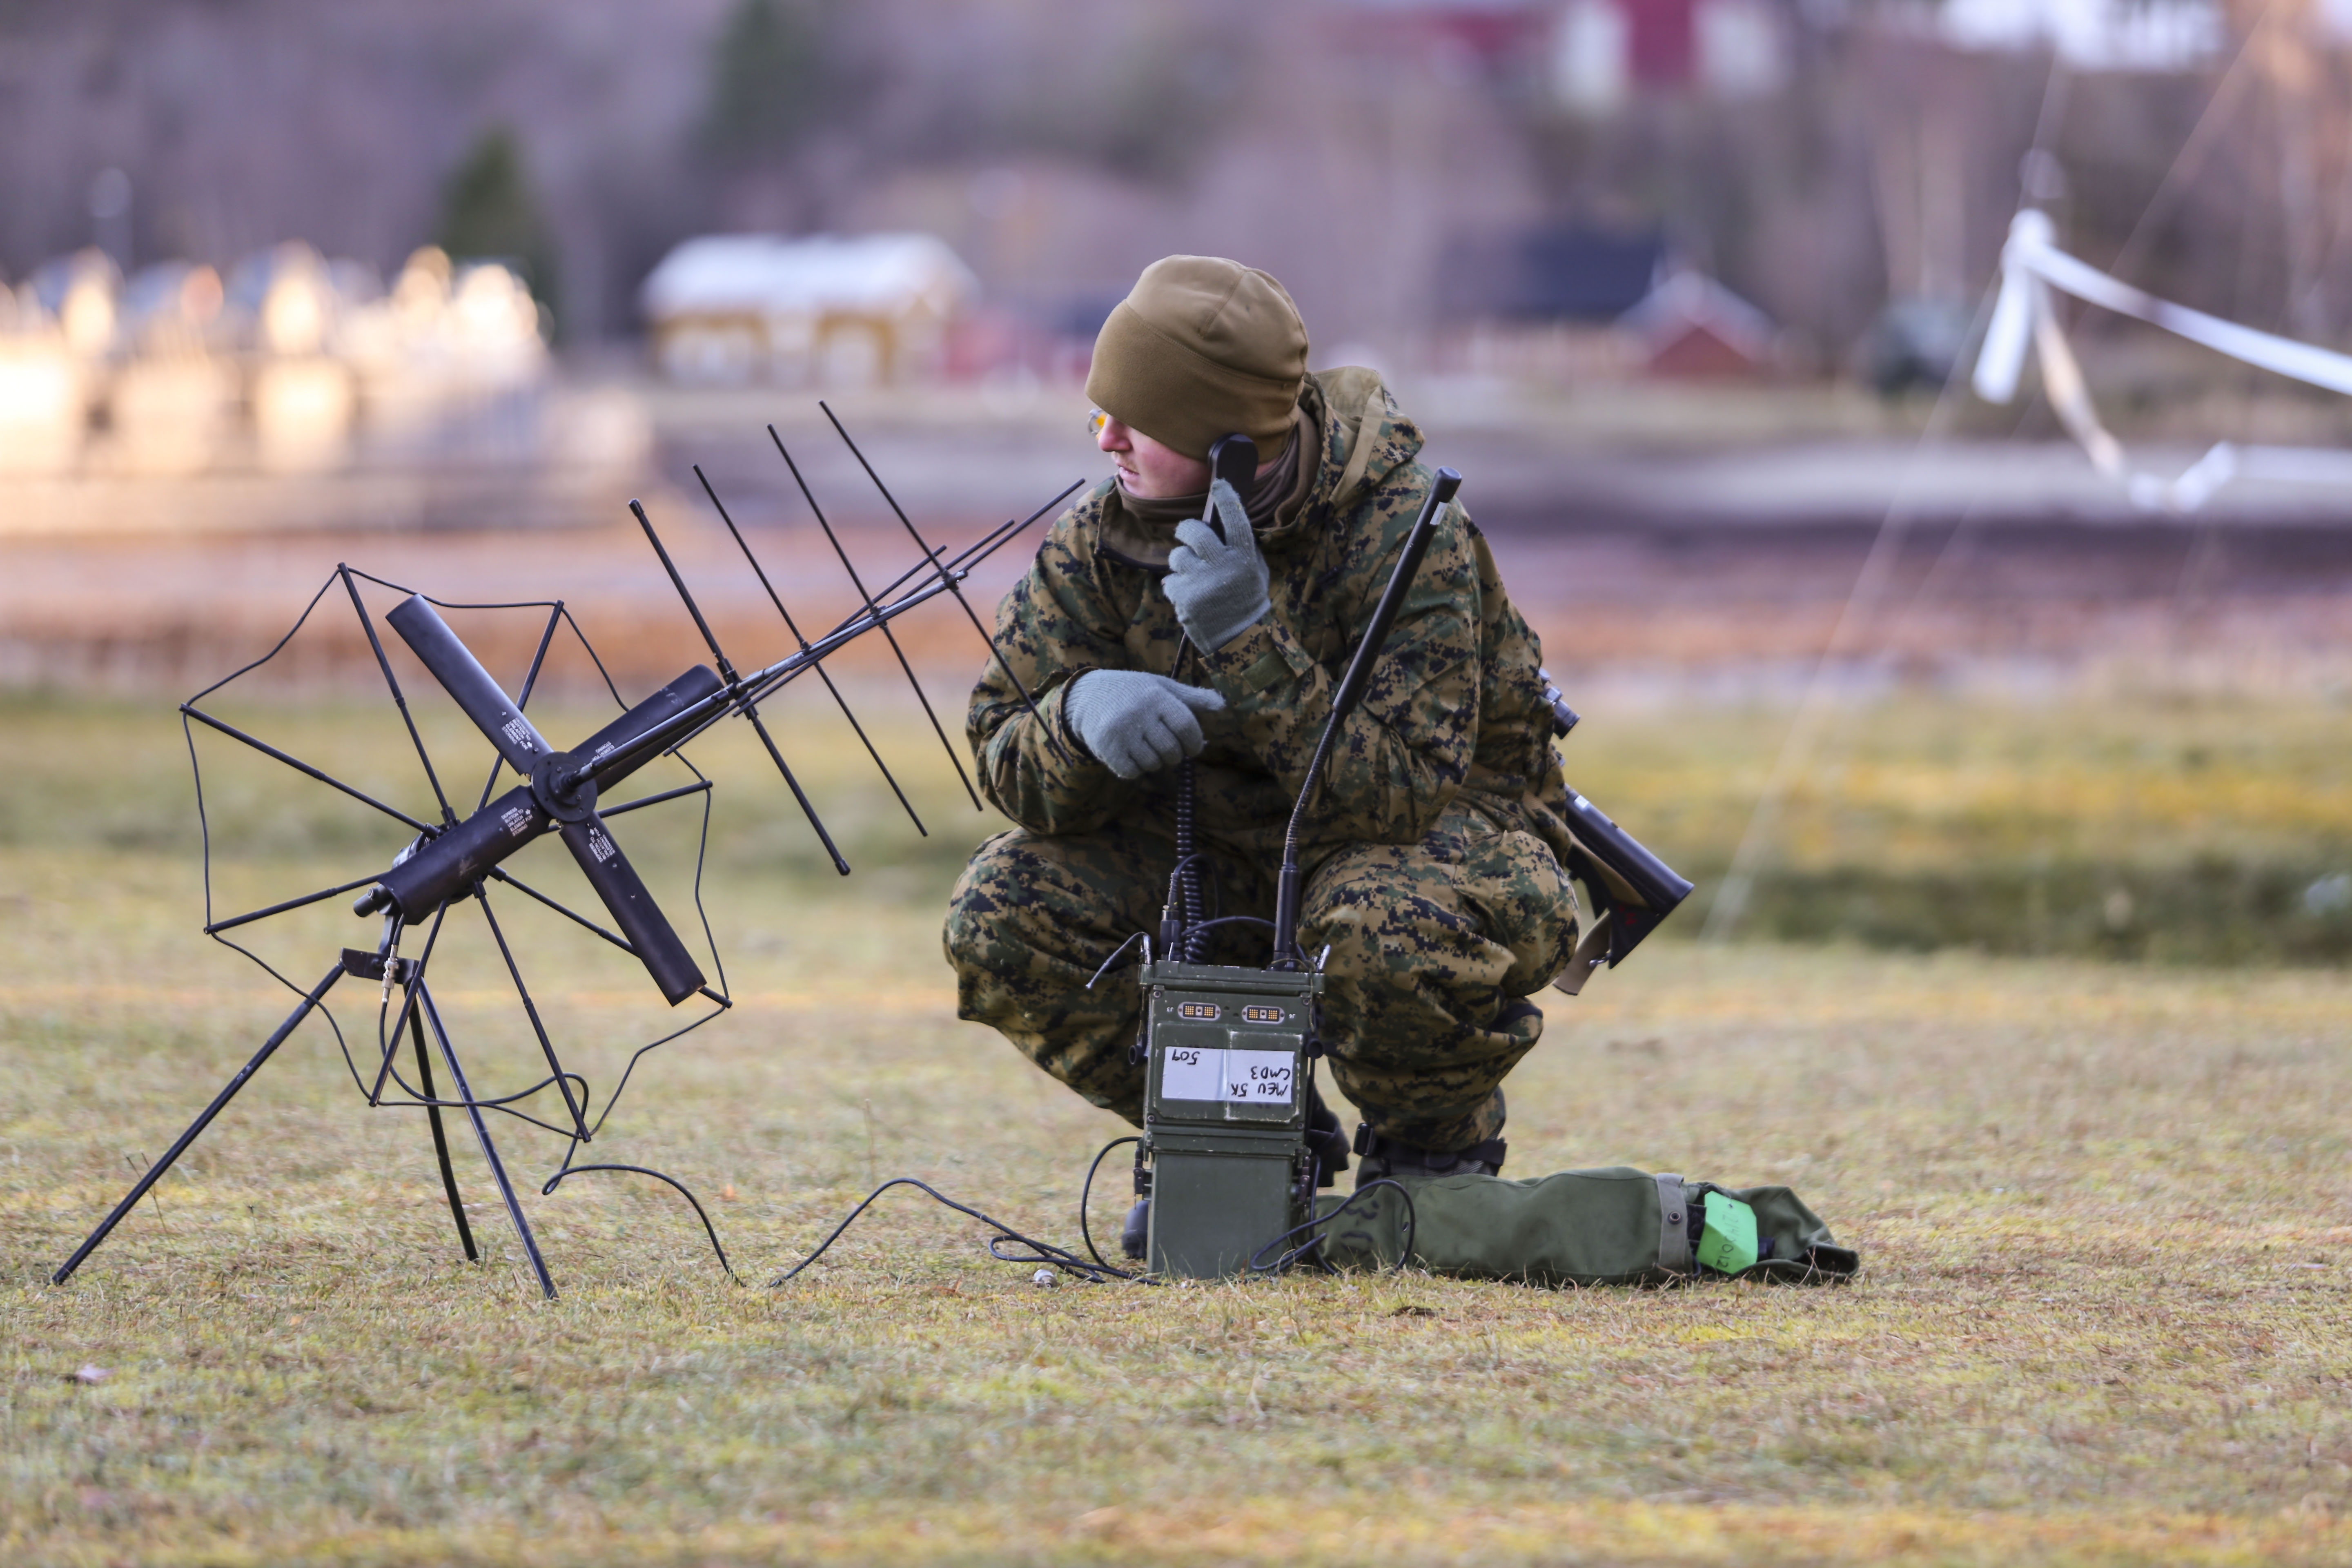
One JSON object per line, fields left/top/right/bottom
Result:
{"left": 1087, "top": 256, "right": 1308, "bottom": 461}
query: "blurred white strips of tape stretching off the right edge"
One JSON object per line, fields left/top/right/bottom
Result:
{"left": 1973, "top": 207, "right": 2352, "bottom": 512}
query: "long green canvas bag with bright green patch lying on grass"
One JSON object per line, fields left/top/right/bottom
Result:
{"left": 1315, "top": 1166, "right": 1860, "bottom": 1286}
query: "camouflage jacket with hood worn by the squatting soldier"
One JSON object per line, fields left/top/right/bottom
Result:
{"left": 967, "top": 367, "right": 1571, "bottom": 865}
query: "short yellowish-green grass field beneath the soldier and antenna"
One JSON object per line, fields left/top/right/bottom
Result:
{"left": 0, "top": 701, "right": 2352, "bottom": 1563}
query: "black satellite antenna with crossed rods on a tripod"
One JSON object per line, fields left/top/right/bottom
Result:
{"left": 52, "top": 402, "right": 1082, "bottom": 1298}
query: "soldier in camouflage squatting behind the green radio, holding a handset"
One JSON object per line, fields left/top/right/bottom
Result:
{"left": 946, "top": 256, "right": 1576, "bottom": 1222}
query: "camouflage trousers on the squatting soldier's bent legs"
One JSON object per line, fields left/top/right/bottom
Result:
{"left": 946, "top": 802, "right": 1576, "bottom": 1152}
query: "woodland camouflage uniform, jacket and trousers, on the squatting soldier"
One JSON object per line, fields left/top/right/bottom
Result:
{"left": 946, "top": 369, "right": 1576, "bottom": 1149}
